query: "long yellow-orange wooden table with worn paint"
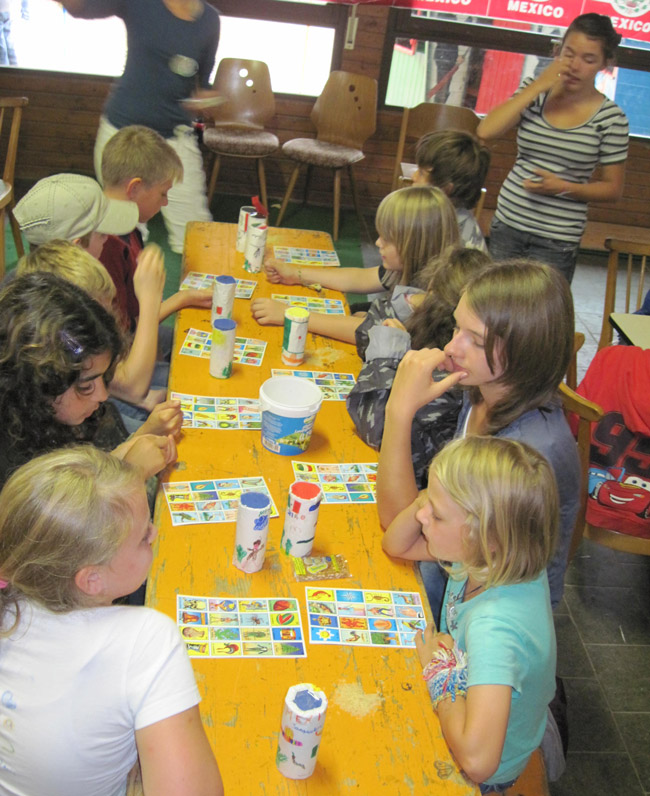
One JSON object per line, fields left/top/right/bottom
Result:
{"left": 147, "top": 223, "right": 478, "bottom": 796}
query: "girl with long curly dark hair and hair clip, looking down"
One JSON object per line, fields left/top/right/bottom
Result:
{"left": 0, "top": 273, "right": 175, "bottom": 484}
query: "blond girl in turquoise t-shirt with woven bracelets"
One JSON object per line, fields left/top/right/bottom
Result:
{"left": 383, "top": 436, "right": 558, "bottom": 793}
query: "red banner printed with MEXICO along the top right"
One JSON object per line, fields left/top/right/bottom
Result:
{"left": 333, "top": 0, "right": 650, "bottom": 41}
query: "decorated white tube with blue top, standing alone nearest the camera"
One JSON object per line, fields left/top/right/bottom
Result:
{"left": 275, "top": 683, "right": 327, "bottom": 779}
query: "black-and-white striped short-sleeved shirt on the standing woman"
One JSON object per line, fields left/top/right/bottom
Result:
{"left": 495, "top": 78, "right": 628, "bottom": 244}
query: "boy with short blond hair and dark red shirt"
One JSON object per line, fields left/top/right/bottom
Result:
{"left": 99, "top": 125, "right": 212, "bottom": 334}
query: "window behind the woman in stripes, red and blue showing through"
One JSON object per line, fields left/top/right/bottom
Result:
{"left": 381, "top": 11, "right": 650, "bottom": 137}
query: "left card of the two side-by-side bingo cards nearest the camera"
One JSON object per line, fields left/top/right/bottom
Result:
{"left": 176, "top": 594, "right": 307, "bottom": 658}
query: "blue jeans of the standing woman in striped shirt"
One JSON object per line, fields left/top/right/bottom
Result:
{"left": 489, "top": 218, "right": 580, "bottom": 284}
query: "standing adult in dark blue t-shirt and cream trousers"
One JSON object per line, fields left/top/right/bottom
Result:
{"left": 54, "top": 0, "right": 219, "bottom": 253}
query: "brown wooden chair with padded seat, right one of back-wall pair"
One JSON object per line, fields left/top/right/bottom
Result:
{"left": 276, "top": 72, "right": 377, "bottom": 240}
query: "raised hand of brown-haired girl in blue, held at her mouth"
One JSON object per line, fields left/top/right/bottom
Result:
{"left": 386, "top": 348, "right": 467, "bottom": 418}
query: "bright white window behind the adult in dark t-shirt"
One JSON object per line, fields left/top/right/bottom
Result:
{"left": 0, "top": 0, "right": 347, "bottom": 96}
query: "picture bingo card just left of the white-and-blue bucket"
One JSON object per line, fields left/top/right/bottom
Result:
{"left": 169, "top": 392, "right": 262, "bottom": 430}
